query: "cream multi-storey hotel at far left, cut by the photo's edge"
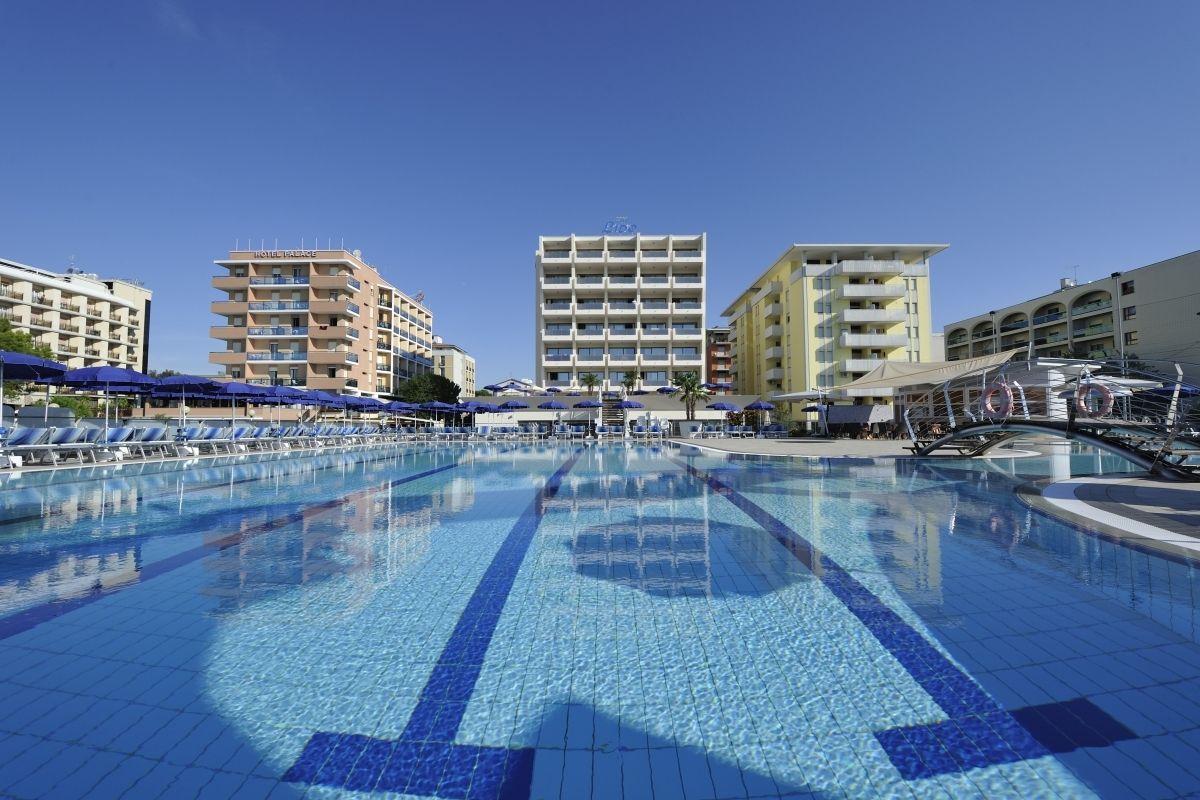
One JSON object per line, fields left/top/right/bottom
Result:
{"left": 0, "top": 259, "right": 151, "bottom": 372}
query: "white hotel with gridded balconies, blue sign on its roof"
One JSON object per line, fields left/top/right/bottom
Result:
{"left": 534, "top": 234, "right": 706, "bottom": 390}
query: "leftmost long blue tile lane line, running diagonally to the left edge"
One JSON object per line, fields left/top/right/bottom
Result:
{"left": 0, "top": 450, "right": 472, "bottom": 639}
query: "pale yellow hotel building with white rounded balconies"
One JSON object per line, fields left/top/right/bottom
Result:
{"left": 722, "top": 243, "right": 947, "bottom": 404}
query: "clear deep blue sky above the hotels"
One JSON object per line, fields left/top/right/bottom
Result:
{"left": 0, "top": 0, "right": 1200, "bottom": 383}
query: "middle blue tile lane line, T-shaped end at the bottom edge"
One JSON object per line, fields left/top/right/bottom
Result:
{"left": 282, "top": 450, "right": 583, "bottom": 800}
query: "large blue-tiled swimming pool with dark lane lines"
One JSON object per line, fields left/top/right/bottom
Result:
{"left": 0, "top": 444, "right": 1200, "bottom": 800}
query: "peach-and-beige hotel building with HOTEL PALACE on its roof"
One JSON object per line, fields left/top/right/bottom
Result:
{"left": 209, "top": 249, "right": 433, "bottom": 397}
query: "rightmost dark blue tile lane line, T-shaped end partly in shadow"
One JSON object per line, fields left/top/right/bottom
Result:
{"left": 673, "top": 459, "right": 1135, "bottom": 780}
